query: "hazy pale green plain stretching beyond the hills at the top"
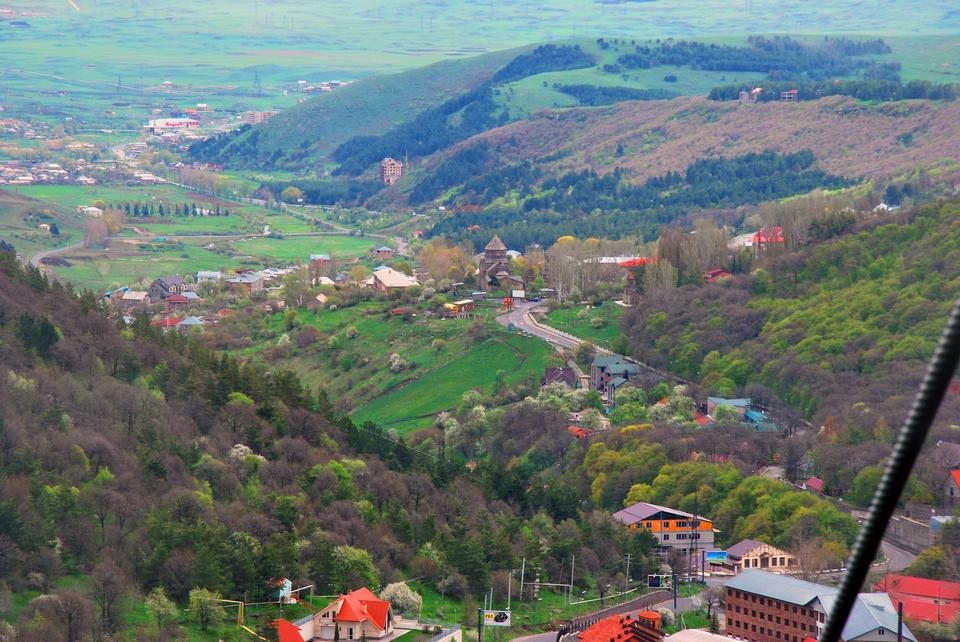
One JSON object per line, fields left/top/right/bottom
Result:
{"left": 0, "top": 0, "right": 960, "bottom": 136}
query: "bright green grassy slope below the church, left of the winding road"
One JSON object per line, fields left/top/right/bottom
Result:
{"left": 235, "top": 301, "right": 553, "bottom": 433}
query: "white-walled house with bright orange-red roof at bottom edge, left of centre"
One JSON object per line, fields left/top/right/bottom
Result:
{"left": 288, "top": 587, "right": 394, "bottom": 641}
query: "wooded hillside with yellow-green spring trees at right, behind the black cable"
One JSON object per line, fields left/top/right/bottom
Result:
{"left": 624, "top": 201, "right": 960, "bottom": 501}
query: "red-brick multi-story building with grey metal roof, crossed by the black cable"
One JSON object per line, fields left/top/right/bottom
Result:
{"left": 724, "top": 569, "right": 916, "bottom": 642}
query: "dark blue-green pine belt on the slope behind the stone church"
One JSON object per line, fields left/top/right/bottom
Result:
{"left": 427, "top": 151, "right": 849, "bottom": 249}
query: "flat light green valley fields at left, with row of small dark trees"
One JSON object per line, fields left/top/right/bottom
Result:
{"left": 0, "top": 185, "right": 381, "bottom": 290}
